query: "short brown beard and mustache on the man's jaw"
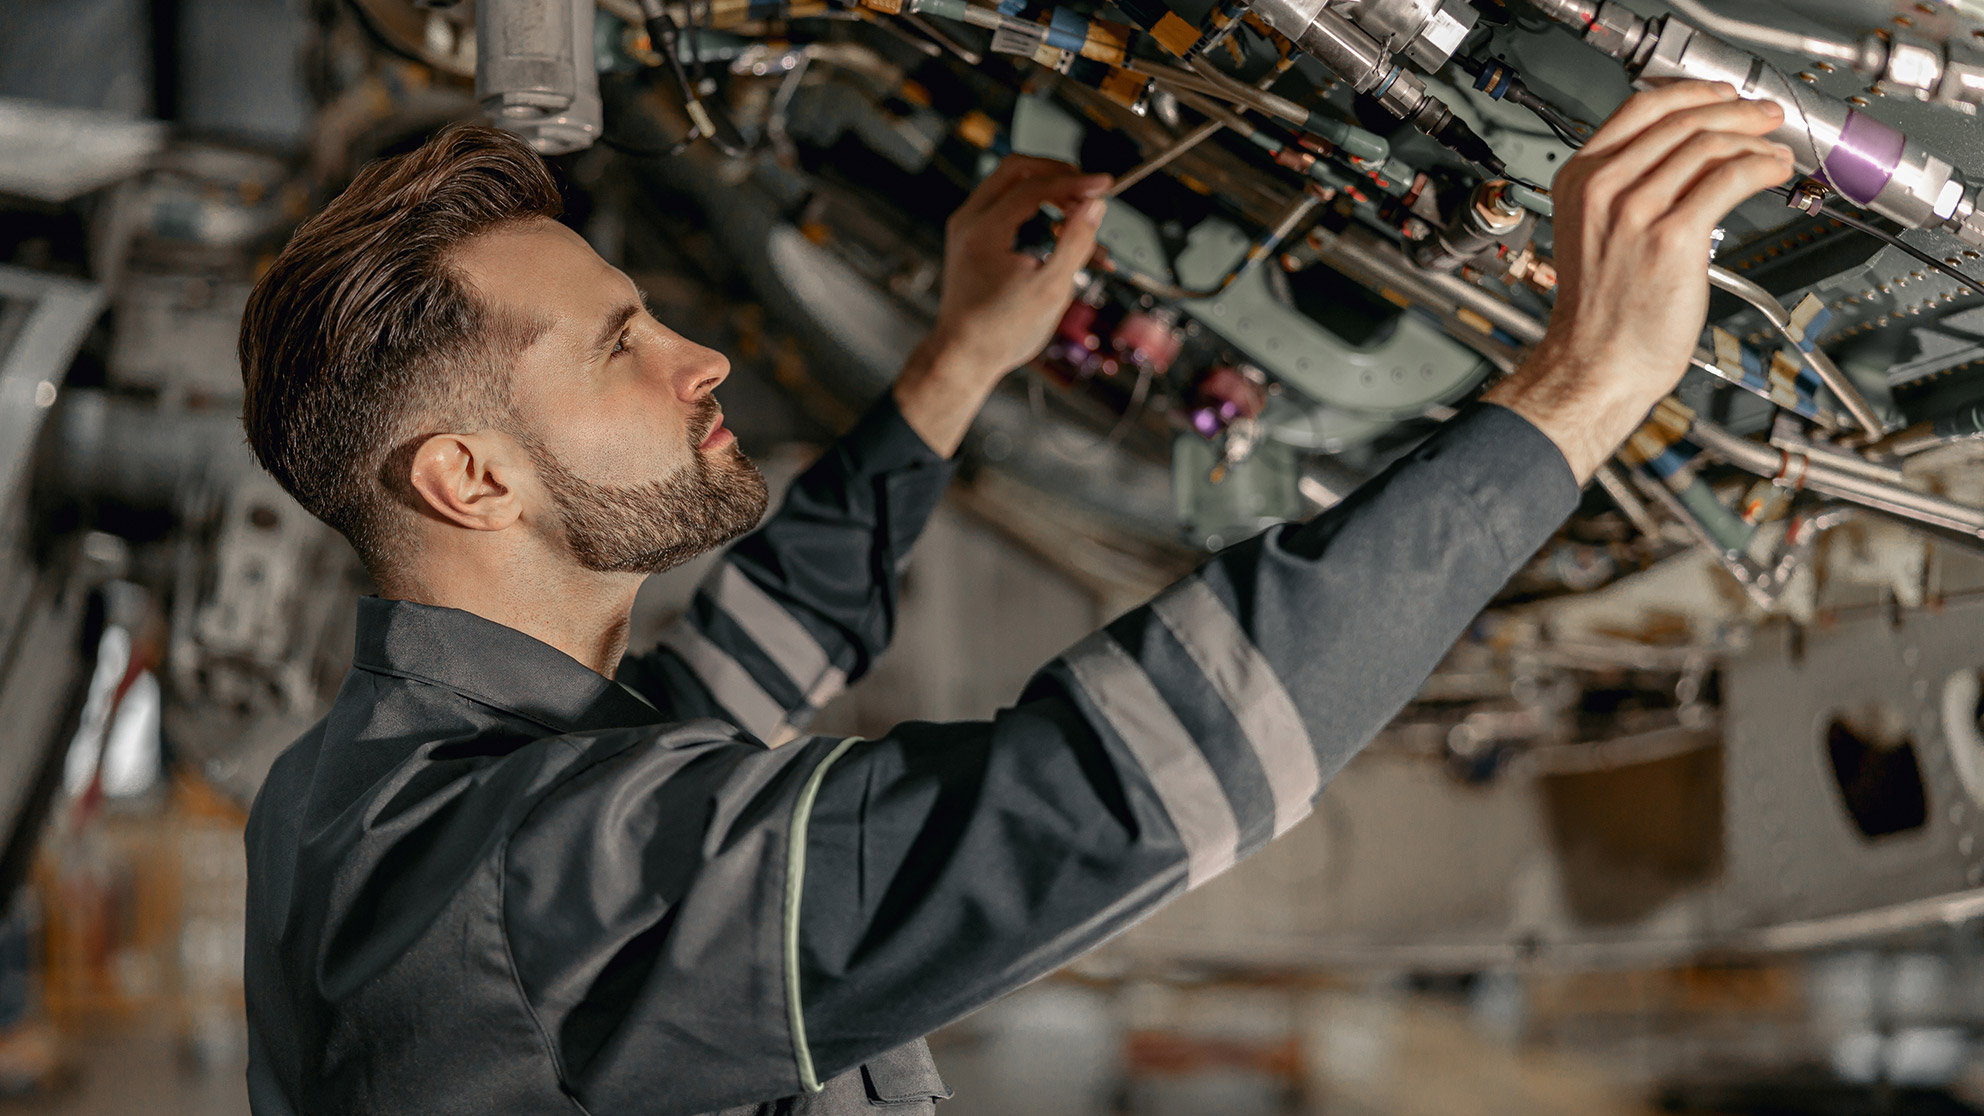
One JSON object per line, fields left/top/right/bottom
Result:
{"left": 520, "top": 399, "right": 766, "bottom": 574}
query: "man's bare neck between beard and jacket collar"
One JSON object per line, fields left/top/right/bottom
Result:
{"left": 379, "top": 562, "right": 643, "bottom": 677}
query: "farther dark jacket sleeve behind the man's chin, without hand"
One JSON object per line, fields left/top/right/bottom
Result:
{"left": 619, "top": 393, "right": 952, "bottom": 747}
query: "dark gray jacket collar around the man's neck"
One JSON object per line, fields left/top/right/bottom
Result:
{"left": 351, "top": 598, "right": 661, "bottom": 733}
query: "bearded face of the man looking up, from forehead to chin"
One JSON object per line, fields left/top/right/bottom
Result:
{"left": 454, "top": 220, "right": 766, "bottom": 574}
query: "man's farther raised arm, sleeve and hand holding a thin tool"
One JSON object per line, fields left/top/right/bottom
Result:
{"left": 619, "top": 157, "right": 1109, "bottom": 745}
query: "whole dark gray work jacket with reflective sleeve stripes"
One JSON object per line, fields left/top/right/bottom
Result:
{"left": 246, "top": 391, "right": 1577, "bottom": 1116}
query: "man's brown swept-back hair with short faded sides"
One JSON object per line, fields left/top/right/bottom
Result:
{"left": 240, "top": 125, "right": 561, "bottom": 578}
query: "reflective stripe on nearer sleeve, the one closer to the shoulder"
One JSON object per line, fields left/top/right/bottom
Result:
{"left": 1063, "top": 631, "right": 1240, "bottom": 888}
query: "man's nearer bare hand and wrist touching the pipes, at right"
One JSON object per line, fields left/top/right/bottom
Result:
{"left": 1484, "top": 81, "right": 1792, "bottom": 485}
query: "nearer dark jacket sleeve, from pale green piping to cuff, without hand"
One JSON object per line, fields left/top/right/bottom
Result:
{"left": 788, "top": 405, "right": 1577, "bottom": 1086}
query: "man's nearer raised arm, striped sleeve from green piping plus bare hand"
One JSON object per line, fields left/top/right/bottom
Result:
{"left": 788, "top": 83, "right": 1792, "bottom": 1076}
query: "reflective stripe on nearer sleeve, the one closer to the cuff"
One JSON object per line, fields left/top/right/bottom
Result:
{"left": 1151, "top": 578, "right": 1323, "bottom": 836}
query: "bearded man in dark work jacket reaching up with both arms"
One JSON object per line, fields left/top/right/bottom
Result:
{"left": 242, "top": 83, "right": 1792, "bottom": 1116}
